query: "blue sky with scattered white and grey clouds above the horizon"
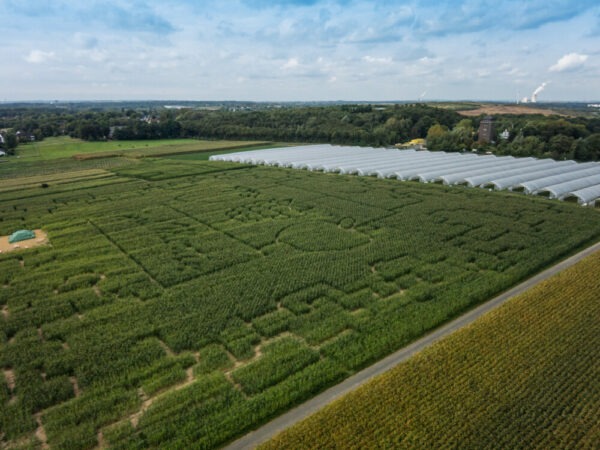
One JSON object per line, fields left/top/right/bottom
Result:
{"left": 0, "top": 0, "right": 600, "bottom": 102}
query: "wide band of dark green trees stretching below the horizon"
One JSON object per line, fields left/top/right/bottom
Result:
{"left": 0, "top": 103, "right": 600, "bottom": 161}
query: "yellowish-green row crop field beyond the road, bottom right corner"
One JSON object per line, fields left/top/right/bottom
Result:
{"left": 260, "top": 253, "right": 600, "bottom": 450}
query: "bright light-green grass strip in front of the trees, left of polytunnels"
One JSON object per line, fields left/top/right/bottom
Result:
{"left": 11, "top": 136, "right": 266, "bottom": 162}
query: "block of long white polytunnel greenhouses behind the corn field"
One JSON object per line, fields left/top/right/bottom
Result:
{"left": 210, "top": 144, "right": 600, "bottom": 206}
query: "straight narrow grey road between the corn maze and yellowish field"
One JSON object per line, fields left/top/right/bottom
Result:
{"left": 225, "top": 242, "right": 600, "bottom": 450}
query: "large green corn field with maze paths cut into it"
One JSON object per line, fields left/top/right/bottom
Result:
{"left": 0, "top": 153, "right": 600, "bottom": 449}
